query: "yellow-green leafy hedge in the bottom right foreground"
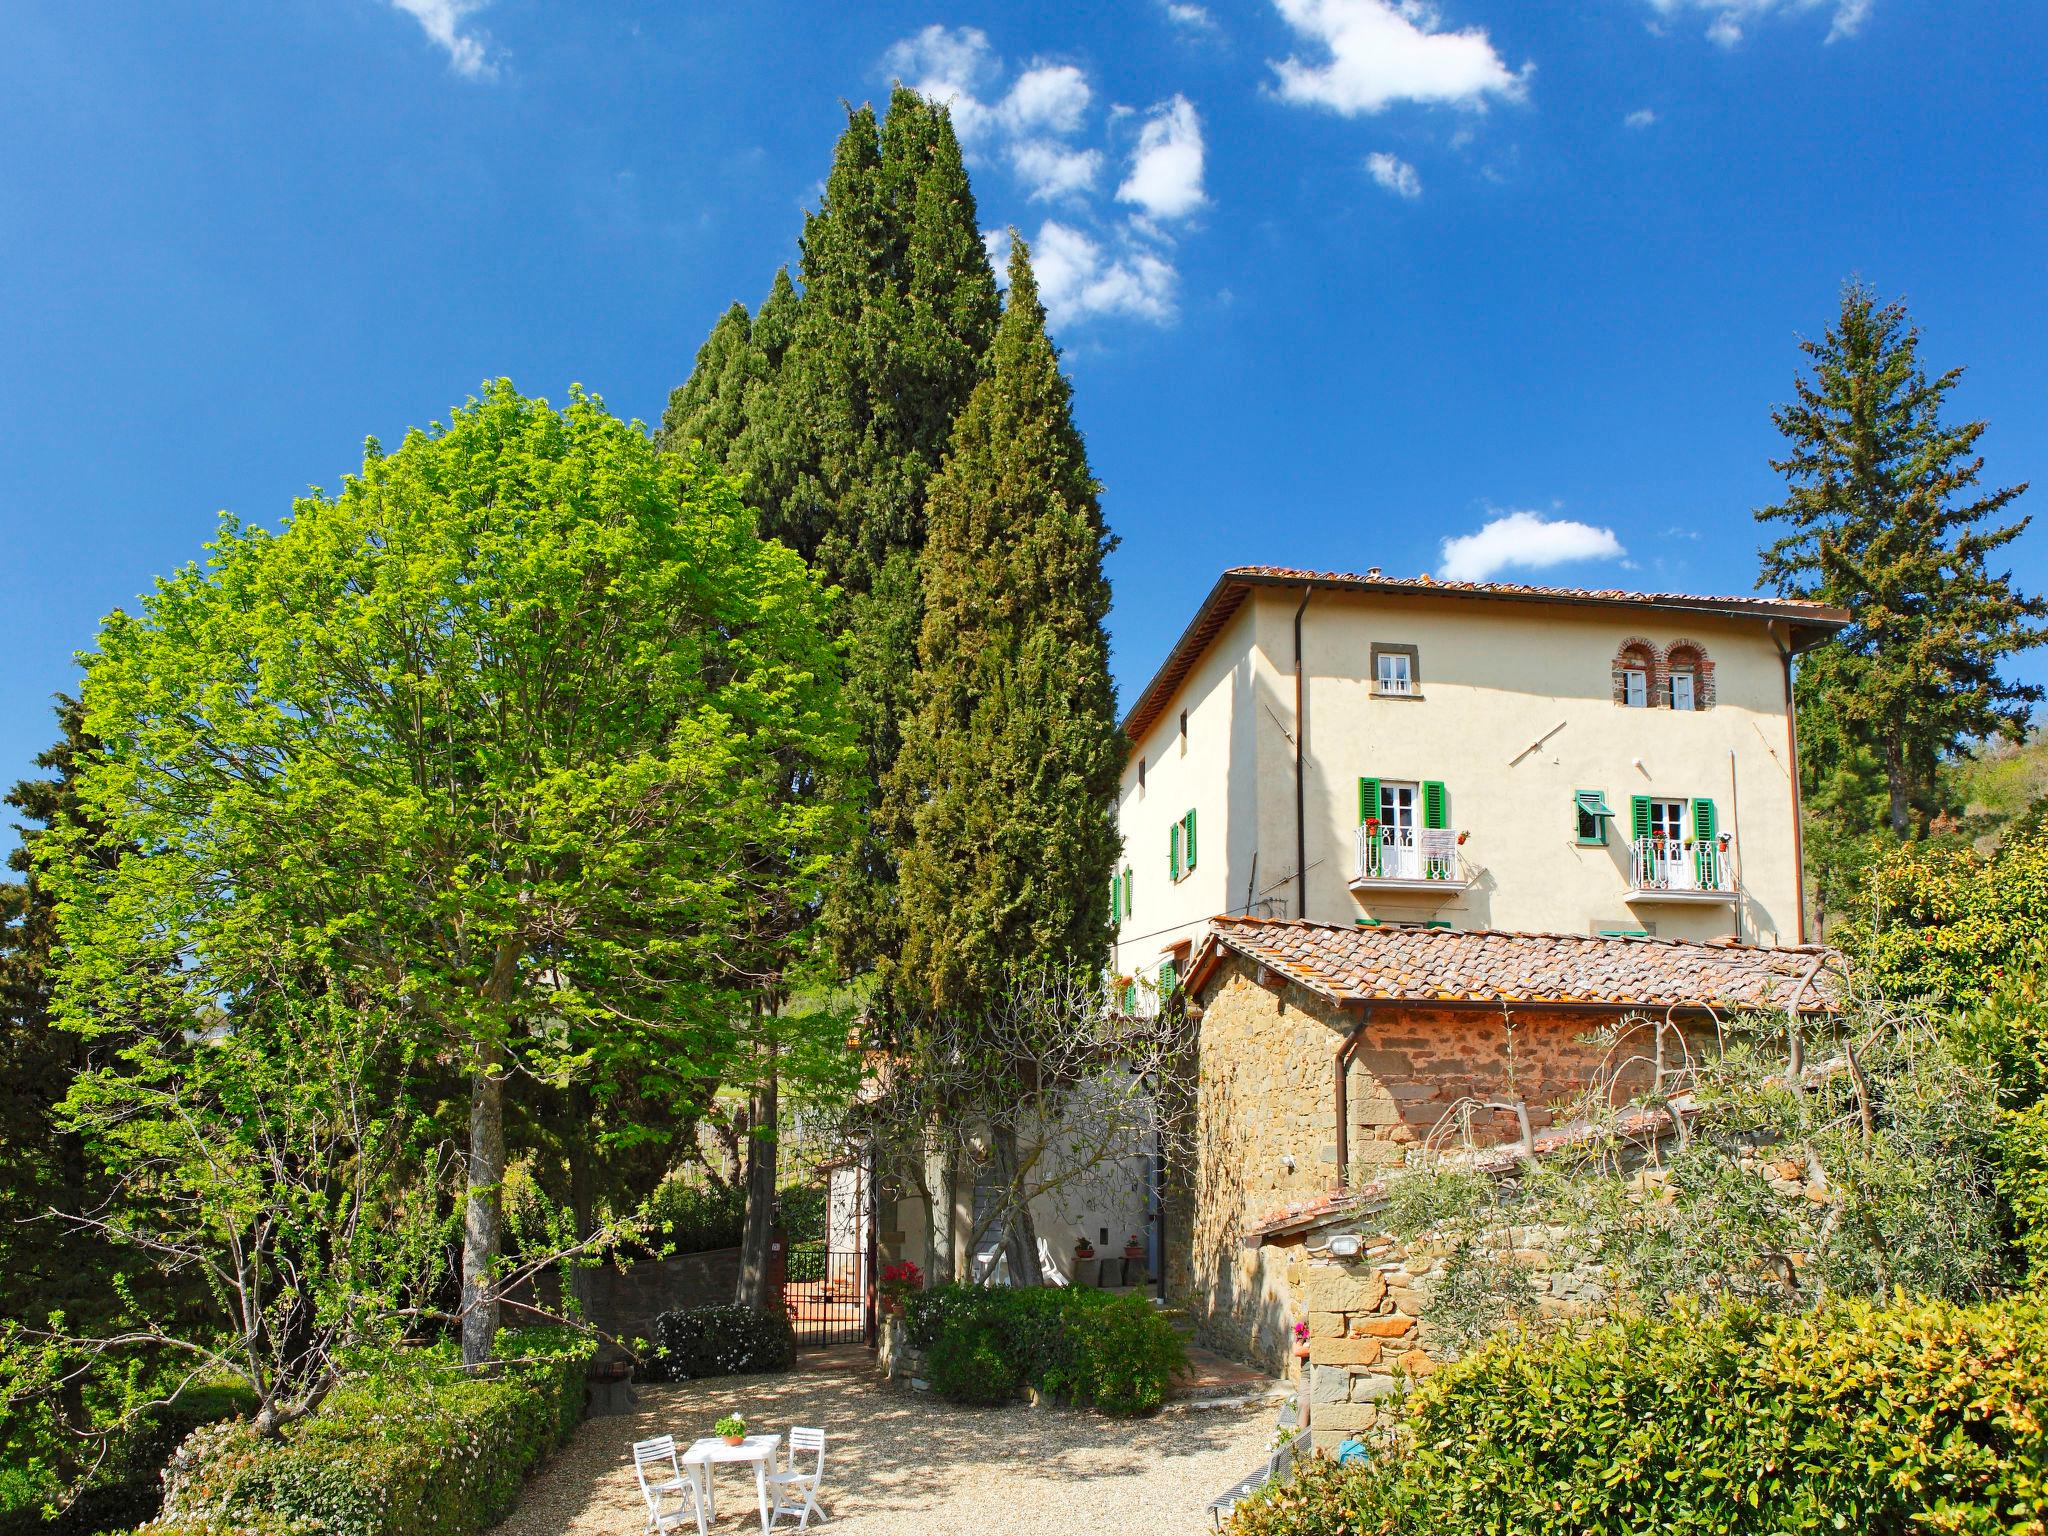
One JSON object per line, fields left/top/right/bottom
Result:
{"left": 1231, "top": 1296, "right": 2048, "bottom": 1536}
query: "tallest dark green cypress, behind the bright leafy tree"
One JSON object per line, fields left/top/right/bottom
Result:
{"left": 664, "top": 86, "right": 999, "bottom": 971}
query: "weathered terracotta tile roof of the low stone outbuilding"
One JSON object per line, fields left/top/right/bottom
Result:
{"left": 1188, "top": 918, "right": 1835, "bottom": 1014}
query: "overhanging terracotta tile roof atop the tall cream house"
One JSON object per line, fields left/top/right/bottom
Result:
{"left": 1124, "top": 565, "right": 1849, "bottom": 743}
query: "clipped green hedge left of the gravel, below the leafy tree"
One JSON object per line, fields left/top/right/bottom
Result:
{"left": 141, "top": 1329, "right": 592, "bottom": 1536}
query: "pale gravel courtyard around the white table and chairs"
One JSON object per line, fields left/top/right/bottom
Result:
{"left": 496, "top": 1352, "right": 1274, "bottom": 1536}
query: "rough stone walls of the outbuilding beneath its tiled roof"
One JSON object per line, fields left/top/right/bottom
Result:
{"left": 1167, "top": 954, "right": 1662, "bottom": 1370}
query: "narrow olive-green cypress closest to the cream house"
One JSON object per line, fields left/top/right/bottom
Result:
{"left": 883, "top": 238, "right": 1124, "bottom": 1284}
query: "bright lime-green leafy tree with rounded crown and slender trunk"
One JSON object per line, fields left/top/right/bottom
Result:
{"left": 47, "top": 381, "right": 858, "bottom": 1362}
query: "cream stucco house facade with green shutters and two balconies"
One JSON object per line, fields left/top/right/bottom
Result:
{"left": 1116, "top": 567, "right": 1841, "bottom": 979}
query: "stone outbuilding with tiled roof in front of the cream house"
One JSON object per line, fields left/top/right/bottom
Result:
{"left": 1165, "top": 918, "right": 1833, "bottom": 1384}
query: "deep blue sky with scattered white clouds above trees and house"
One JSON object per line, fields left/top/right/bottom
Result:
{"left": 0, "top": 0, "right": 2048, "bottom": 831}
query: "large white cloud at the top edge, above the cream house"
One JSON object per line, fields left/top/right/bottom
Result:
{"left": 1272, "top": 0, "right": 1531, "bottom": 117}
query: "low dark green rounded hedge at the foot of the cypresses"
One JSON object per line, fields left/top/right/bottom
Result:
{"left": 903, "top": 1286, "right": 1188, "bottom": 1415}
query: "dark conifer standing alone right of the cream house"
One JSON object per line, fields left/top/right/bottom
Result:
{"left": 1757, "top": 283, "right": 2048, "bottom": 836}
